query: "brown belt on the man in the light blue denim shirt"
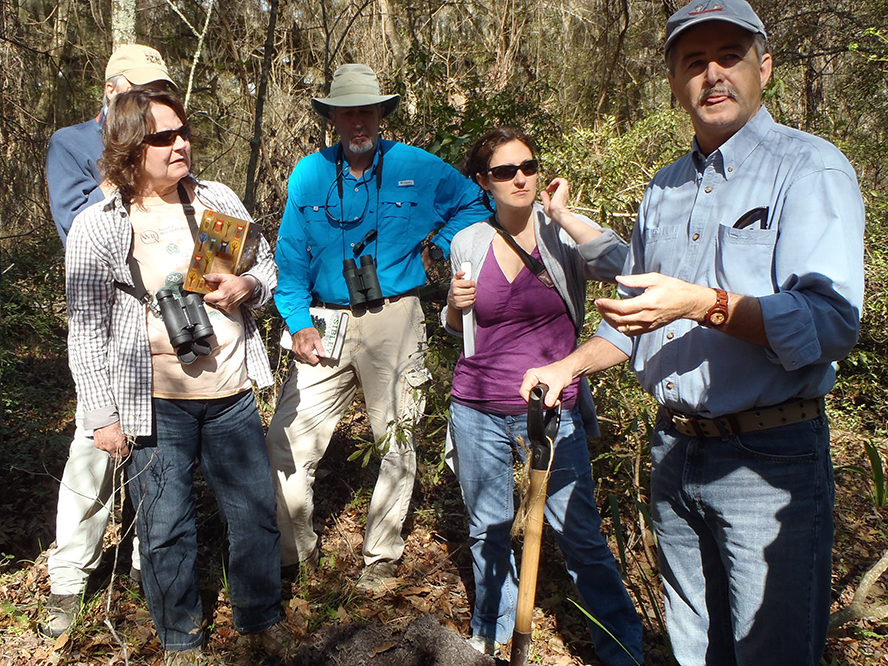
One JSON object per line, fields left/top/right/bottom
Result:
{"left": 663, "top": 398, "right": 826, "bottom": 437}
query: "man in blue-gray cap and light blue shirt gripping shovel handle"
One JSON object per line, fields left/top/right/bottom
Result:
{"left": 522, "top": 0, "right": 864, "bottom": 666}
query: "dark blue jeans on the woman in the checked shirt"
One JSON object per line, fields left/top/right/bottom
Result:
{"left": 128, "top": 391, "right": 281, "bottom": 651}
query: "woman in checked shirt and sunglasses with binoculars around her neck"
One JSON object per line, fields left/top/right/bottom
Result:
{"left": 66, "top": 89, "right": 293, "bottom": 664}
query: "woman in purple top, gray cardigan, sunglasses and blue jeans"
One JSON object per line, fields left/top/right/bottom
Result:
{"left": 442, "top": 128, "right": 643, "bottom": 666}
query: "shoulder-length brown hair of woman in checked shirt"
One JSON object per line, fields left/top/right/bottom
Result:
{"left": 99, "top": 88, "right": 188, "bottom": 202}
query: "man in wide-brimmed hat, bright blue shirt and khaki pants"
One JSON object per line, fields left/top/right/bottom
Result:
{"left": 268, "top": 64, "right": 489, "bottom": 592}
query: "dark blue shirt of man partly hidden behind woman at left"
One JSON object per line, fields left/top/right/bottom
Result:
{"left": 46, "top": 112, "right": 105, "bottom": 245}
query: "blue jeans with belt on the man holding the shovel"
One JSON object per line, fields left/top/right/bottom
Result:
{"left": 651, "top": 414, "right": 835, "bottom": 666}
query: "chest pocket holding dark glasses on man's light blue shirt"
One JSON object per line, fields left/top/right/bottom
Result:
{"left": 715, "top": 225, "right": 777, "bottom": 296}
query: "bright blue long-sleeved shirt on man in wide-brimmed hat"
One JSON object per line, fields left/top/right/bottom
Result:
{"left": 274, "top": 140, "right": 490, "bottom": 332}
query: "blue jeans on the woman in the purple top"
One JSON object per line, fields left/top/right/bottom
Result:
{"left": 450, "top": 403, "right": 644, "bottom": 666}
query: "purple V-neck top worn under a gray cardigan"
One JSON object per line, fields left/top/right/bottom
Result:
{"left": 451, "top": 244, "right": 579, "bottom": 415}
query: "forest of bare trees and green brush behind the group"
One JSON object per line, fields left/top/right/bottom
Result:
{"left": 0, "top": 0, "right": 888, "bottom": 664}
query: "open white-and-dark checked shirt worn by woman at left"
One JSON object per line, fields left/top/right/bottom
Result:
{"left": 65, "top": 180, "right": 277, "bottom": 437}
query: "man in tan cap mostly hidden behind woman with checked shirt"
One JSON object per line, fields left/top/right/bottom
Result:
{"left": 40, "top": 44, "right": 176, "bottom": 637}
